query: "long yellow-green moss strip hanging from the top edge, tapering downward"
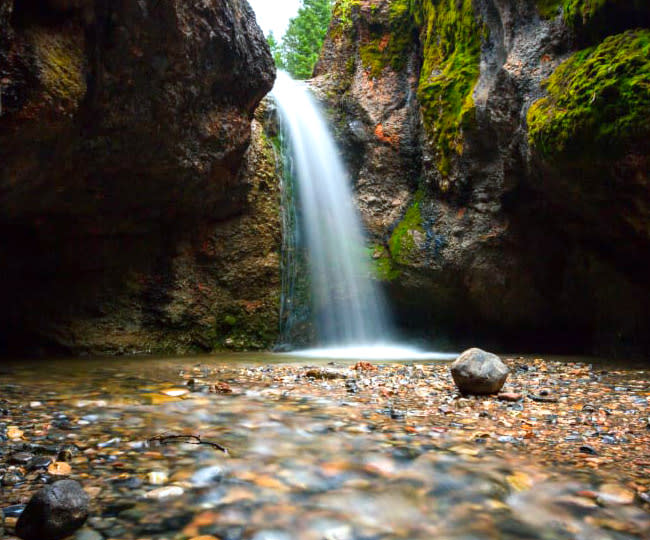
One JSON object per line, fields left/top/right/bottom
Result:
{"left": 410, "top": 0, "right": 484, "bottom": 178}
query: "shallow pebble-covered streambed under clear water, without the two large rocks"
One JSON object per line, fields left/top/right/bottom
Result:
{"left": 0, "top": 354, "right": 650, "bottom": 540}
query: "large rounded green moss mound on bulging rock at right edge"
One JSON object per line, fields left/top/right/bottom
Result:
{"left": 528, "top": 30, "right": 650, "bottom": 160}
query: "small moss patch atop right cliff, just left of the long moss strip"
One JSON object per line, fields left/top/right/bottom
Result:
{"left": 359, "top": 0, "right": 414, "bottom": 77}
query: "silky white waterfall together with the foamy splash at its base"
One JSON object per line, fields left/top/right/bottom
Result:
{"left": 272, "top": 72, "right": 453, "bottom": 359}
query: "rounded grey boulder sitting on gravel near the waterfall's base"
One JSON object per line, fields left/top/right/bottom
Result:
{"left": 451, "top": 349, "right": 510, "bottom": 395}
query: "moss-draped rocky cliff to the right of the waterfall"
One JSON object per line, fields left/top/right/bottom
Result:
{"left": 314, "top": 0, "right": 650, "bottom": 353}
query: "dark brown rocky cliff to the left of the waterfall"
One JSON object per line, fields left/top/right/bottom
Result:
{"left": 0, "top": 0, "right": 280, "bottom": 353}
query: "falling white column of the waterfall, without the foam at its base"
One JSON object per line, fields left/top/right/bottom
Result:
{"left": 272, "top": 72, "right": 390, "bottom": 346}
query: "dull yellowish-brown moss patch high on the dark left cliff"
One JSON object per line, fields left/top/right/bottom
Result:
{"left": 31, "top": 29, "right": 86, "bottom": 105}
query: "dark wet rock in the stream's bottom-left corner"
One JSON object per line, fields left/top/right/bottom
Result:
{"left": 16, "top": 480, "right": 90, "bottom": 540}
